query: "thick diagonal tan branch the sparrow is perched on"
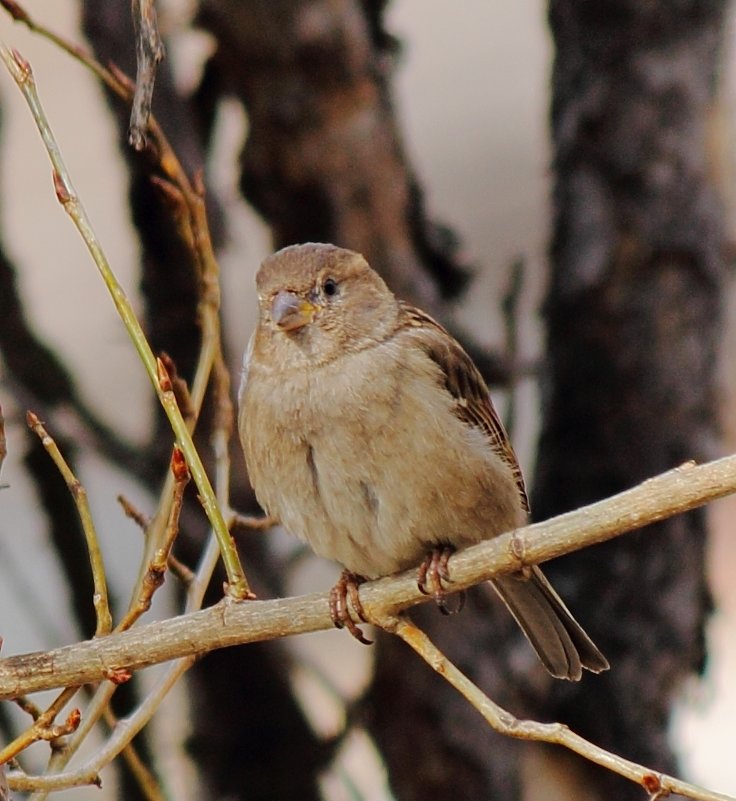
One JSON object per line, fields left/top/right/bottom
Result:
{"left": 0, "top": 456, "right": 736, "bottom": 700}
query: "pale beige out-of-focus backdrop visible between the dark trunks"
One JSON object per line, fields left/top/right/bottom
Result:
{"left": 0, "top": 0, "right": 736, "bottom": 799}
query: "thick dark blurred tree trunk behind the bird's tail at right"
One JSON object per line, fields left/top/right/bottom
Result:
{"left": 533, "top": 0, "right": 726, "bottom": 799}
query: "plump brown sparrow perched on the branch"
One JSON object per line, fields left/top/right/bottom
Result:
{"left": 238, "top": 244, "right": 608, "bottom": 680}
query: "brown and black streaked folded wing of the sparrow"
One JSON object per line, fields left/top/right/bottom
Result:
{"left": 399, "top": 302, "right": 529, "bottom": 512}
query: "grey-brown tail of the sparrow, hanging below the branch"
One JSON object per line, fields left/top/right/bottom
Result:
{"left": 491, "top": 566, "right": 609, "bottom": 681}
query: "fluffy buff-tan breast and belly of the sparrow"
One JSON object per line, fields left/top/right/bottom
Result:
{"left": 240, "top": 340, "right": 518, "bottom": 577}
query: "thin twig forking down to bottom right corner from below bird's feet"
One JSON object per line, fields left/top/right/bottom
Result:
{"left": 386, "top": 616, "right": 735, "bottom": 801}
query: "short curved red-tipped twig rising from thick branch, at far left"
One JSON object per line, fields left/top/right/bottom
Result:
{"left": 26, "top": 412, "right": 112, "bottom": 637}
